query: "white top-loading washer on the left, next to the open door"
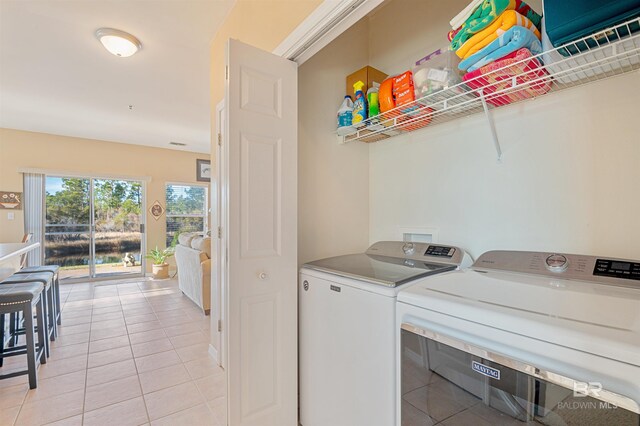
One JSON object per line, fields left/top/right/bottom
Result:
{"left": 299, "top": 241, "right": 472, "bottom": 426}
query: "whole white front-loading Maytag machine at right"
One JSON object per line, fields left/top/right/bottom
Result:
{"left": 396, "top": 251, "right": 640, "bottom": 426}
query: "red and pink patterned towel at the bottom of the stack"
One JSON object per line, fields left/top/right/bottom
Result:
{"left": 462, "top": 49, "right": 552, "bottom": 106}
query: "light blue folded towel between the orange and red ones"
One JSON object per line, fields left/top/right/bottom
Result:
{"left": 458, "top": 25, "right": 542, "bottom": 71}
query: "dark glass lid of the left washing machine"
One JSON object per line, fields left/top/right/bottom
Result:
{"left": 304, "top": 254, "right": 456, "bottom": 287}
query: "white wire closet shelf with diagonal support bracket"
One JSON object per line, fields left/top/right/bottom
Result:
{"left": 338, "top": 18, "right": 640, "bottom": 146}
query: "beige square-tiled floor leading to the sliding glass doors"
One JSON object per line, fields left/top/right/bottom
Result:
{"left": 0, "top": 279, "right": 226, "bottom": 426}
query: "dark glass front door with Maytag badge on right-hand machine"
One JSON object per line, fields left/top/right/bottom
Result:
{"left": 401, "top": 324, "right": 640, "bottom": 426}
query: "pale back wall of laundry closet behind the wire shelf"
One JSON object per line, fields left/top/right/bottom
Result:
{"left": 369, "top": 0, "right": 640, "bottom": 259}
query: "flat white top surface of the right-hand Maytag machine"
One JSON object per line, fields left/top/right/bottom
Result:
{"left": 398, "top": 270, "right": 640, "bottom": 366}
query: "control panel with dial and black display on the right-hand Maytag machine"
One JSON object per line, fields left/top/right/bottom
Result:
{"left": 473, "top": 250, "right": 640, "bottom": 288}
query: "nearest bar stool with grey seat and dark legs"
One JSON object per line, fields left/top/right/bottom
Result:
{"left": 0, "top": 282, "right": 48, "bottom": 389}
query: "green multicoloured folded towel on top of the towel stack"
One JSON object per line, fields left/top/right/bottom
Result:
{"left": 451, "top": 0, "right": 542, "bottom": 50}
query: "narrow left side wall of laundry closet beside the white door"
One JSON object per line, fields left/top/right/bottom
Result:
{"left": 298, "top": 20, "right": 369, "bottom": 264}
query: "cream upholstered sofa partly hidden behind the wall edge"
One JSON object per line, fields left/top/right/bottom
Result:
{"left": 175, "top": 233, "right": 211, "bottom": 315}
